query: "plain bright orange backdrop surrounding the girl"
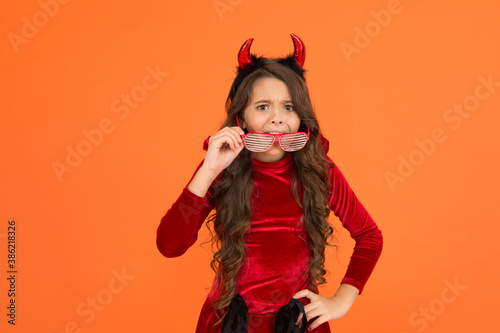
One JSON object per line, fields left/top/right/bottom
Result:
{"left": 0, "top": 0, "right": 500, "bottom": 333}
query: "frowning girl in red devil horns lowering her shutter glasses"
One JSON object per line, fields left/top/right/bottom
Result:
{"left": 157, "top": 34, "right": 382, "bottom": 333}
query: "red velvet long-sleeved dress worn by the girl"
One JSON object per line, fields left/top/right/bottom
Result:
{"left": 157, "top": 139, "right": 382, "bottom": 333}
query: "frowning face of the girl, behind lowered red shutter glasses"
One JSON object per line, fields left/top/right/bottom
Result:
{"left": 243, "top": 78, "right": 300, "bottom": 162}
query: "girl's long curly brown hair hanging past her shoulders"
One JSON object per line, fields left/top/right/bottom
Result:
{"left": 207, "top": 63, "right": 333, "bottom": 323}
